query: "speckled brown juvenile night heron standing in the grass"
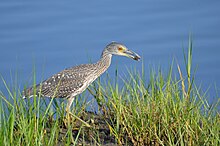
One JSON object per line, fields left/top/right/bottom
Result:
{"left": 23, "top": 42, "right": 140, "bottom": 111}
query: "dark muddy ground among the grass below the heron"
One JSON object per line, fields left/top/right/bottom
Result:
{"left": 46, "top": 112, "right": 128, "bottom": 146}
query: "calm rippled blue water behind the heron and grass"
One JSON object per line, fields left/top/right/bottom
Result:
{"left": 0, "top": 0, "right": 220, "bottom": 106}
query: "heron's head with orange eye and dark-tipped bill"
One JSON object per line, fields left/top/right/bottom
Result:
{"left": 105, "top": 42, "right": 141, "bottom": 61}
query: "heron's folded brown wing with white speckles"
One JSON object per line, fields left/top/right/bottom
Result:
{"left": 38, "top": 65, "right": 94, "bottom": 97}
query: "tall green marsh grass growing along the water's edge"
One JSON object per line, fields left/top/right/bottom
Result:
{"left": 0, "top": 39, "right": 220, "bottom": 146}
